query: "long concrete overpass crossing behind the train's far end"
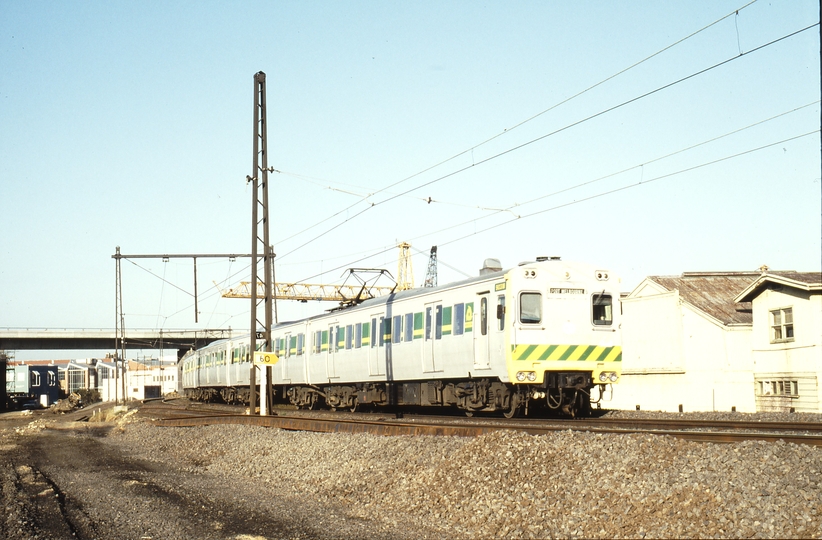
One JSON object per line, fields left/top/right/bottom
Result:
{"left": 0, "top": 328, "right": 235, "bottom": 355}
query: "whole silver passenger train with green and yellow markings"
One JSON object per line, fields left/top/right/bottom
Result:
{"left": 180, "top": 257, "right": 622, "bottom": 417}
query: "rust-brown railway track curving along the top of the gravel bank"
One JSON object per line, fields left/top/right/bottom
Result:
{"left": 140, "top": 402, "right": 822, "bottom": 446}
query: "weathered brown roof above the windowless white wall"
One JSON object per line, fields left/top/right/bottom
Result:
{"left": 649, "top": 272, "right": 762, "bottom": 324}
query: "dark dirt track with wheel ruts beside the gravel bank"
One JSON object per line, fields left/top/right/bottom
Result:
{"left": 0, "top": 409, "right": 402, "bottom": 540}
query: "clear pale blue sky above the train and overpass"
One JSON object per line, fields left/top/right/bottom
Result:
{"left": 0, "top": 0, "right": 822, "bottom": 358}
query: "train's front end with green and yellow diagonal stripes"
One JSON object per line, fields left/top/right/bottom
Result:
{"left": 505, "top": 258, "right": 622, "bottom": 416}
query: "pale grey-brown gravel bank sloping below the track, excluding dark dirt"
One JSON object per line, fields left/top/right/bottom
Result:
{"left": 1, "top": 410, "right": 822, "bottom": 538}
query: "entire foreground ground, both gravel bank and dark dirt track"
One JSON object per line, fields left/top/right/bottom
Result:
{"left": 0, "top": 408, "right": 822, "bottom": 539}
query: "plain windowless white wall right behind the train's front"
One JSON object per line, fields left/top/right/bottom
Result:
{"left": 602, "top": 281, "right": 756, "bottom": 412}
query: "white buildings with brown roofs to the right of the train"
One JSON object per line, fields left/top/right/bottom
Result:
{"left": 616, "top": 271, "right": 822, "bottom": 412}
